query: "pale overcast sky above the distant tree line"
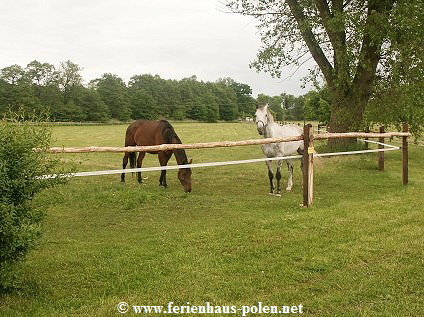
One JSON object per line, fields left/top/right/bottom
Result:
{"left": 0, "top": 0, "right": 309, "bottom": 97}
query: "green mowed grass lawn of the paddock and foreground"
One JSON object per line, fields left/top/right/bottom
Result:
{"left": 0, "top": 123, "right": 424, "bottom": 316}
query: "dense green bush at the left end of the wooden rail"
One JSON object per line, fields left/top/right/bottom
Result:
{"left": 0, "top": 115, "right": 64, "bottom": 290}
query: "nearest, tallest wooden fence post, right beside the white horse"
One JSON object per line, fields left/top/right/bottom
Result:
{"left": 303, "top": 124, "right": 314, "bottom": 207}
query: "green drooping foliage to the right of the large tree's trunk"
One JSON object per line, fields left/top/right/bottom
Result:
{"left": 366, "top": 0, "right": 424, "bottom": 136}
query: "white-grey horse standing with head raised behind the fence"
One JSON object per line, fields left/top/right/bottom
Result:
{"left": 255, "top": 104, "right": 303, "bottom": 196}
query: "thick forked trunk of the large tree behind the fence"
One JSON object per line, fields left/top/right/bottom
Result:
{"left": 286, "top": 0, "right": 396, "bottom": 148}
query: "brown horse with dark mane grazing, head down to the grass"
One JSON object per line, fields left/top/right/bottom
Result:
{"left": 121, "top": 120, "right": 192, "bottom": 193}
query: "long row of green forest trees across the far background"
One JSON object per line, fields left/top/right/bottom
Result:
{"left": 0, "top": 60, "right": 329, "bottom": 123}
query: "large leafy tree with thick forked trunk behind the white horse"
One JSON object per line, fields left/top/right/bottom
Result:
{"left": 227, "top": 0, "right": 424, "bottom": 136}
